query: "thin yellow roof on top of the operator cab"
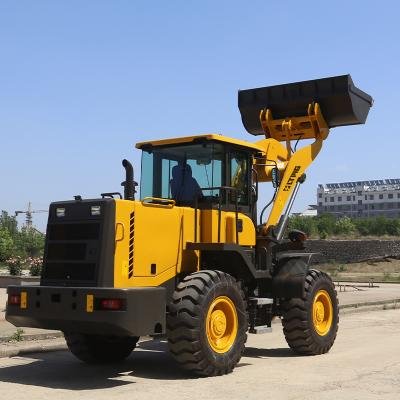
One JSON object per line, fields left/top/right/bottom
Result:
{"left": 136, "top": 133, "right": 264, "bottom": 152}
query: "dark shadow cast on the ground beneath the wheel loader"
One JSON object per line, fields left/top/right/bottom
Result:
{"left": 0, "top": 341, "right": 293, "bottom": 390}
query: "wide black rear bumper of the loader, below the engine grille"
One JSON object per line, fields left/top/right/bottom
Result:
{"left": 6, "top": 286, "right": 166, "bottom": 336}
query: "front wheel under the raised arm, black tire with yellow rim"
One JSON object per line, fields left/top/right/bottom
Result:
{"left": 282, "top": 270, "right": 339, "bottom": 355}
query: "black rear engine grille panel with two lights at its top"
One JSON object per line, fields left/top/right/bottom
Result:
{"left": 40, "top": 198, "right": 115, "bottom": 287}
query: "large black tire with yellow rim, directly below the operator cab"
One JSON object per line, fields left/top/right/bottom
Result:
{"left": 167, "top": 270, "right": 248, "bottom": 376}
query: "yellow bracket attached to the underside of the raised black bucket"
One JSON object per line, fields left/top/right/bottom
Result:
{"left": 260, "top": 102, "right": 329, "bottom": 142}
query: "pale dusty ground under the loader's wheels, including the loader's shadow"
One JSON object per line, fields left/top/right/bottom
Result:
{"left": 0, "top": 310, "right": 400, "bottom": 400}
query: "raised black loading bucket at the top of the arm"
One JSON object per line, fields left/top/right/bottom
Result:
{"left": 238, "top": 75, "right": 373, "bottom": 135}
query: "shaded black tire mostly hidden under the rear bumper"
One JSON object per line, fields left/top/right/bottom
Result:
{"left": 64, "top": 332, "right": 139, "bottom": 364}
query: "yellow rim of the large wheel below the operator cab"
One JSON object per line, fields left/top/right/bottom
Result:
{"left": 206, "top": 296, "right": 238, "bottom": 353}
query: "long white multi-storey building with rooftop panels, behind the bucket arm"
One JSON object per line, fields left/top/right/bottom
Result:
{"left": 317, "top": 179, "right": 400, "bottom": 218}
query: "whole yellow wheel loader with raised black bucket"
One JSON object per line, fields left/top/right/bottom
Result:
{"left": 6, "top": 75, "right": 372, "bottom": 376}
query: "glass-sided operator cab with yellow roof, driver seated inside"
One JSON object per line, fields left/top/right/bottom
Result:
{"left": 136, "top": 135, "right": 260, "bottom": 216}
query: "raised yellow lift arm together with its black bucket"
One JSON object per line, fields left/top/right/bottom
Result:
{"left": 238, "top": 75, "right": 373, "bottom": 240}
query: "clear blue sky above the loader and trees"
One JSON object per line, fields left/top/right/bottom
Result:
{"left": 0, "top": 0, "right": 400, "bottom": 229}
